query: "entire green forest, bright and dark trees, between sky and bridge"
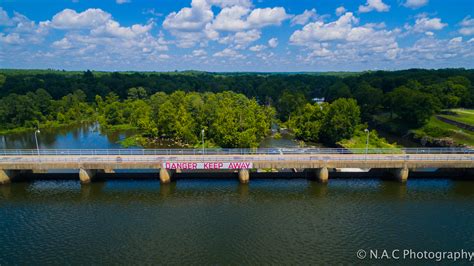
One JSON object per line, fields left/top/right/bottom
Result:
{"left": 0, "top": 69, "right": 474, "bottom": 147}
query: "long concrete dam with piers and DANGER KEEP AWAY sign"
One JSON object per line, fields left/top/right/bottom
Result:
{"left": 0, "top": 148, "right": 474, "bottom": 184}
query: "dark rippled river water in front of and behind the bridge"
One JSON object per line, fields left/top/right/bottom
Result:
{"left": 0, "top": 125, "right": 474, "bottom": 265}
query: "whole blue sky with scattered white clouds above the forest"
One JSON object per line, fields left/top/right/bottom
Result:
{"left": 0, "top": 0, "right": 474, "bottom": 72}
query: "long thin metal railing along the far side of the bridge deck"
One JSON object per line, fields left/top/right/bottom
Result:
{"left": 0, "top": 148, "right": 474, "bottom": 156}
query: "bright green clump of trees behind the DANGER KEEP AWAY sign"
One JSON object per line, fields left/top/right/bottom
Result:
{"left": 96, "top": 87, "right": 275, "bottom": 147}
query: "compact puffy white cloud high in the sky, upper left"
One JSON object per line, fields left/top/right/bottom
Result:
{"left": 47, "top": 8, "right": 112, "bottom": 29}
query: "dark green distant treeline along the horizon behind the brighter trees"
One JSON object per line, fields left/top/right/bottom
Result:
{"left": 0, "top": 69, "right": 474, "bottom": 126}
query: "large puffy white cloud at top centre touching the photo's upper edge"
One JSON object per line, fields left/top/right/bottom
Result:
{"left": 163, "top": 0, "right": 291, "bottom": 49}
